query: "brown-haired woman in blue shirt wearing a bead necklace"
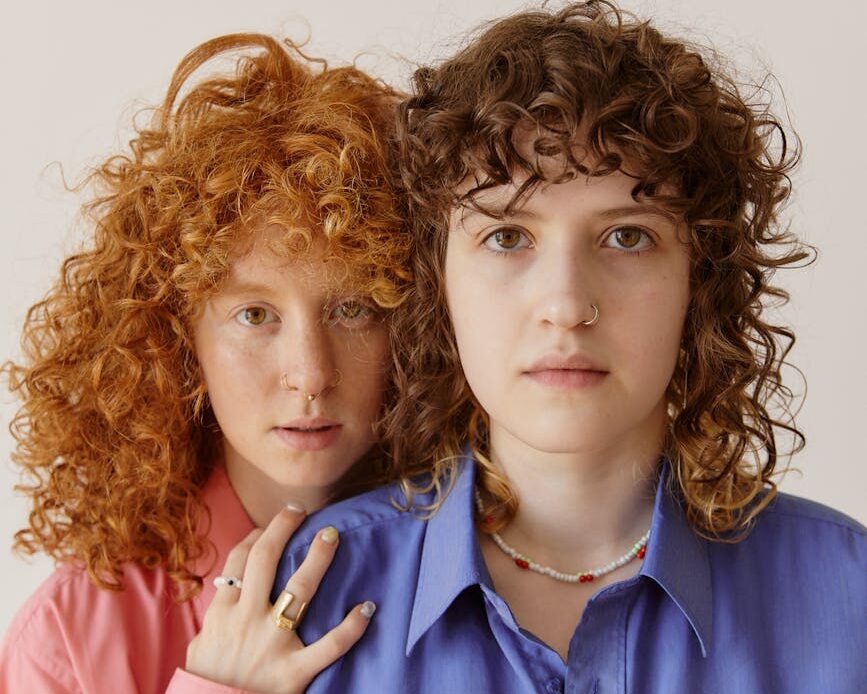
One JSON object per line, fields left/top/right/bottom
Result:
{"left": 268, "top": 2, "right": 867, "bottom": 694}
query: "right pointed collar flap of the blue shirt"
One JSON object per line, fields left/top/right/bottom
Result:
{"left": 639, "top": 460, "right": 713, "bottom": 657}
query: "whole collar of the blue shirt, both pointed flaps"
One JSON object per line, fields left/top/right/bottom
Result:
{"left": 406, "top": 455, "right": 713, "bottom": 656}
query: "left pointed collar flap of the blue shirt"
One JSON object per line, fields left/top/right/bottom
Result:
{"left": 406, "top": 456, "right": 491, "bottom": 655}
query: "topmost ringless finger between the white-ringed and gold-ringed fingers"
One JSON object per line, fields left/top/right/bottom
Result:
{"left": 241, "top": 505, "right": 307, "bottom": 610}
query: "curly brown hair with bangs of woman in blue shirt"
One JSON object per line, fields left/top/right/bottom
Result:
{"left": 388, "top": 2, "right": 809, "bottom": 539}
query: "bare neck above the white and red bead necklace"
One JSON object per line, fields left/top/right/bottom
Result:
{"left": 491, "top": 428, "right": 660, "bottom": 571}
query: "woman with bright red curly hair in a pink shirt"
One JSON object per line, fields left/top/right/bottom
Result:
{"left": 0, "top": 29, "right": 408, "bottom": 692}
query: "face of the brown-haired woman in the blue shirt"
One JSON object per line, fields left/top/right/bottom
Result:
{"left": 445, "top": 172, "right": 689, "bottom": 462}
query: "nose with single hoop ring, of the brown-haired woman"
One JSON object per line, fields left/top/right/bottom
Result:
{"left": 536, "top": 251, "right": 599, "bottom": 329}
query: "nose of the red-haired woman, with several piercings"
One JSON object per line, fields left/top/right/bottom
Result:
{"left": 278, "top": 315, "right": 339, "bottom": 400}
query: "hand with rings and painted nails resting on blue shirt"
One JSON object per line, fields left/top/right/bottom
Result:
{"left": 186, "top": 507, "right": 375, "bottom": 693}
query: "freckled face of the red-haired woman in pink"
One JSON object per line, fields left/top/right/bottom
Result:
{"left": 195, "top": 228, "right": 387, "bottom": 510}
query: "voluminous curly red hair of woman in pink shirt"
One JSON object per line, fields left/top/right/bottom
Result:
{"left": 3, "top": 34, "right": 408, "bottom": 595}
